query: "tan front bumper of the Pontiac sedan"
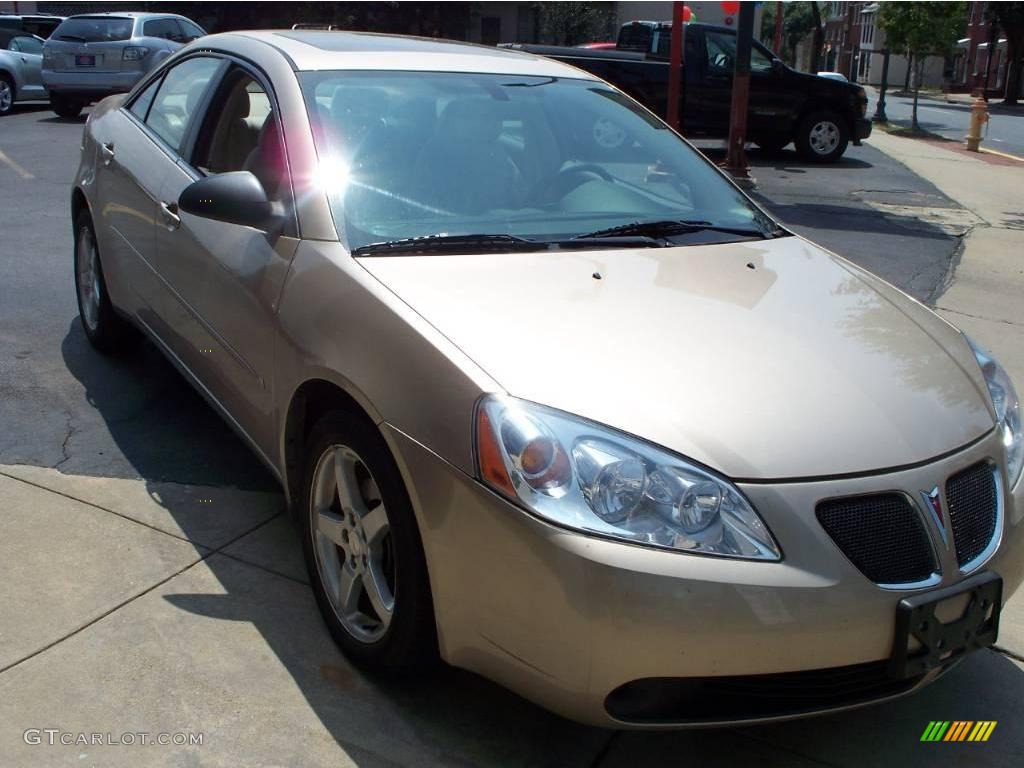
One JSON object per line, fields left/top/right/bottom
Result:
{"left": 384, "top": 426, "right": 1024, "bottom": 728}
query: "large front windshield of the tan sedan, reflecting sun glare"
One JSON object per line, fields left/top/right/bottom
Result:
{"left": 300, "top": 72, "right": 773, "bottom": 250}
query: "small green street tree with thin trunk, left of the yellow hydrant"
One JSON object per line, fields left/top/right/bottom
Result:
{"left": 879, "top": 2, "right": 967, "bottom": 132}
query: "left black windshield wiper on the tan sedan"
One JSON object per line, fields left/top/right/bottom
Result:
{"left": 352, "top": 233, "right": 665, "bottom": 256}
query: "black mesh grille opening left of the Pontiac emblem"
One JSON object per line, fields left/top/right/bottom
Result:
{"left": 817, "top": 494, "right": 937, "bottom": 584}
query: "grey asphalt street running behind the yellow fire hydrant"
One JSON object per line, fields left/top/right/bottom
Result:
{"left": 867, "top": 88, "right": 1024, "bottom": 158}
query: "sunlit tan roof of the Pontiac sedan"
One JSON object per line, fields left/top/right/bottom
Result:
{"left": 220, "top": 30, "right": 597, "bottom": 80}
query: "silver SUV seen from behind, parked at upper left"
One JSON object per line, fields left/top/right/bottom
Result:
{"left": 43, "top": 13, "right": 206, "bottom": 118}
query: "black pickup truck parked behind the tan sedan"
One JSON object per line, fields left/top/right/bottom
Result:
{"left": 510, "top": 22, "right": 871, "bottom": 163}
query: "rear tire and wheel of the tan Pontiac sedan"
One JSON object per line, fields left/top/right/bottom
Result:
{"left": 75, "top": 211, "right": 137, "bottom": 355}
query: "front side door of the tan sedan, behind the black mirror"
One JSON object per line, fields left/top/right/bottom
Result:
{"left": 157, "top": 63, "right": 298, "bottom": 455}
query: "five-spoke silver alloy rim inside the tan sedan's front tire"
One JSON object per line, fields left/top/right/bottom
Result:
{"left": 309, "top": 444, "right": 395, "bottom": 643}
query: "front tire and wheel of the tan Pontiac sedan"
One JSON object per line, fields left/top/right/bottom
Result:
{"left": 299, "top": 411, "right": 437, "bottom": 673}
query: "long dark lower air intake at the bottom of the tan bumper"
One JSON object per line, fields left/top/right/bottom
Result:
{"left": 604, "top": 660, "right": 921, "bottom": 723}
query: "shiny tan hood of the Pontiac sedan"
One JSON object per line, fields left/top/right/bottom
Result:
{"left": 360, "top": 237, "right": 994, "bottom": 479}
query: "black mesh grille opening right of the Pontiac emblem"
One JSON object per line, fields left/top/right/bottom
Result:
{"left": 946, "top": 462, "right": 998, "bottom": 567}
